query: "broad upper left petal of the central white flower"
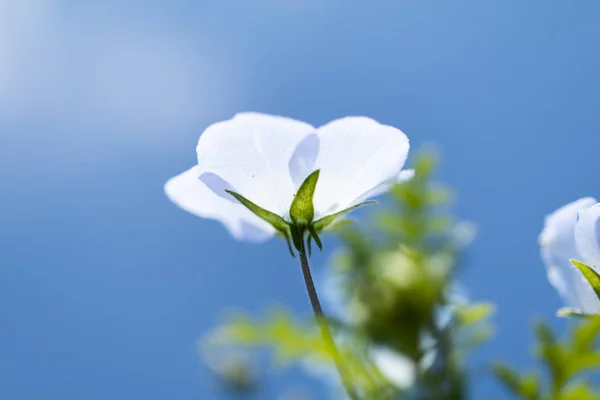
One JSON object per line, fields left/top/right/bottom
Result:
{"left": 197, "top": 113, "right": 315, "bottom": 216}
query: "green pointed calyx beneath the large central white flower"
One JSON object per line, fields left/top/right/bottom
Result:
{"left": 226, "top": 170, "right": 377, "bottom": 257}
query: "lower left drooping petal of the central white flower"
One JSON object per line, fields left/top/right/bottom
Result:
{"left": 165, "top": 166, "right": 274, "bottom": 242}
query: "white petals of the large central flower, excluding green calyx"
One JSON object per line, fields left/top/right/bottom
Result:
{"left": 165, "top": 113, "right": 412, "bottom": 242}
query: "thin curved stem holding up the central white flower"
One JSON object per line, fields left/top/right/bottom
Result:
{"left": 298, "top": 234, "right": 360, "bottom": 400}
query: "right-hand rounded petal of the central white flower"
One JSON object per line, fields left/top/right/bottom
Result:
{"left": 314, "top": 117, "right": 409, "bottom": 216}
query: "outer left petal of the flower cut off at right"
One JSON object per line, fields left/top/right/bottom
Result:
{"left": 539, "top": 197, "right": 600, "bottom": 312}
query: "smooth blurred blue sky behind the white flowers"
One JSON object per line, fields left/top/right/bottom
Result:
{"left": 0, "top": 0, "right": 600, "bottom": 399}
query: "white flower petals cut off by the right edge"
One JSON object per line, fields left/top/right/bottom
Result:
{"left": 539, "top": 197, "right": 600, "bottom": 314}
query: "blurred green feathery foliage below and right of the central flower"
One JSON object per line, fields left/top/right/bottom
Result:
{"left": 205, "top": 148, "right": 493, "bottom": 400}
